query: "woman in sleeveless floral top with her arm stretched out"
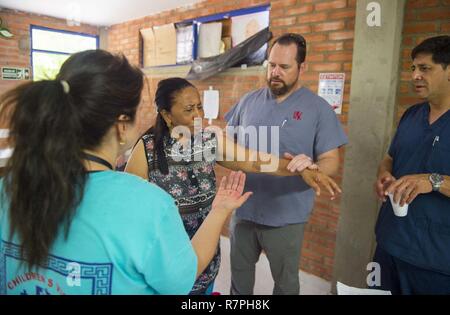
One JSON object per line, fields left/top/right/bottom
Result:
{"left": 125, "top": 78, "right": 340, "bottom": 294}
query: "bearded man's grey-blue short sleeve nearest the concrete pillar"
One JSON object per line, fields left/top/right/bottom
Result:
{"left": 314, "top": 100, "right": 348, "bottom": 158}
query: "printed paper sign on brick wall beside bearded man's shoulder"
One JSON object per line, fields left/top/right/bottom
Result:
{"left": 317, "top": 73, "right": 345, "bottom": 114}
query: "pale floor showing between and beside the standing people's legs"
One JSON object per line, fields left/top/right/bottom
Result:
{"left": 214, "top": 237, "right": 331, "bottom": 295}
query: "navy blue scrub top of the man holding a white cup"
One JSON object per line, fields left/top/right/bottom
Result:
{"left": 375, "top": 103, "right": 450, "bottom": 275}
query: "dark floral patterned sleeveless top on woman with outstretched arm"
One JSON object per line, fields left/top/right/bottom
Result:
{"left": 142, "top": 132, "right": 220, "bottom": 294}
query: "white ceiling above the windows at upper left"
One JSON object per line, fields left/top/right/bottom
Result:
{"left": 0, "top": 0, "right": 200, "bottom": 26}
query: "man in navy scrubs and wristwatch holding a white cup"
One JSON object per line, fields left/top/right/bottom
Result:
{"left": 374, "top": 36, "right": 450, "bottom": 294}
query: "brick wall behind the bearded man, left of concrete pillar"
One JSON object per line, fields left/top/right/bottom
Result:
{"left": 108, "top": 0, "right": 356, "bottom": 280}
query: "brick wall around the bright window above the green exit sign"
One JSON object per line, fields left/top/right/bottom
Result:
{"left": 0, "top": 9, "right": 98, "bottom": 94}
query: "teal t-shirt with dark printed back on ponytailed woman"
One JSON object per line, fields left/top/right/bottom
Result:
{"left": 0, "top": 171, "right": 197, "bottom": 295}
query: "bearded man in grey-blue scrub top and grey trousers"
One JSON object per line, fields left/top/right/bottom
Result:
{"left": 225, "top": 33, "right": 347, "bottom": 294}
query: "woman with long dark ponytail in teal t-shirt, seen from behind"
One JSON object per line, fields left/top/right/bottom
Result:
{"left": 0, "top": 50, "right": 249, "bottom": 294}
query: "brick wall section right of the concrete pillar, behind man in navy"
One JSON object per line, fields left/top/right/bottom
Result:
{"left": 396, "top": 0, "right": 450, "bottom": 122}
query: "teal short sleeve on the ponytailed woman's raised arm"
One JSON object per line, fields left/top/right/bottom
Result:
{"left": 143, "top": 203, "right": 197, "bottom": 294}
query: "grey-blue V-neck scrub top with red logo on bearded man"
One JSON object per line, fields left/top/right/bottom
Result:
{"left": 225, "top": 87, "right": 348, "bottom": 227}
